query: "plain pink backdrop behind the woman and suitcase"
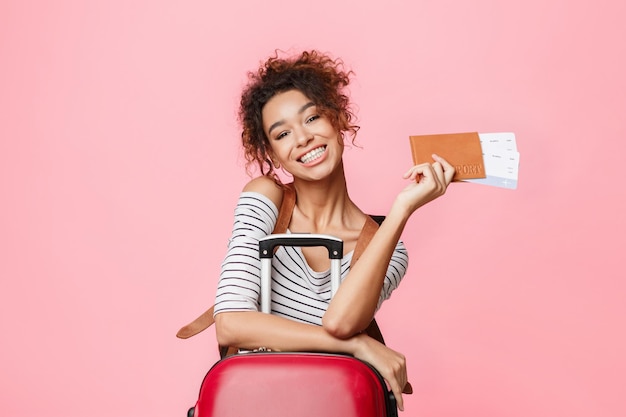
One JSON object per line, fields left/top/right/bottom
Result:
{"left": 0, "top": 0, "right": 626, "bottom": 417}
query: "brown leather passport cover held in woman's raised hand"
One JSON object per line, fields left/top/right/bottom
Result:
{"left": 409, "top": 132, "right": 486, "bottom": 181}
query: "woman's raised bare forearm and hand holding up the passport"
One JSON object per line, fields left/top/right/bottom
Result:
{"left": 322, "top": 155, "right": 454, "bottom": 338}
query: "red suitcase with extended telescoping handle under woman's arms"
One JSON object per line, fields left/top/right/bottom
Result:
{"left": 188, "top": 234, "right": 398, "bottom": 417}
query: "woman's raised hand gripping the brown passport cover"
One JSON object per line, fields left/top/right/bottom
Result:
{"left": 396, "top": 154, "right": 455, "bottom": 214}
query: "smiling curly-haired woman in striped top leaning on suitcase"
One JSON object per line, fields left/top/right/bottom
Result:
{"left": 215, "top": 51, "right": 454, "bottom": 410}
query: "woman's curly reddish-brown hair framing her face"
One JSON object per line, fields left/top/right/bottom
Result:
{"left": 239, "top": 50, "right": 359, "bottom": 180}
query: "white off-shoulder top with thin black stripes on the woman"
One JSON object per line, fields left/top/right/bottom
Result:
{"left": 215, "top": 192, "right": 408, "bottom": 325}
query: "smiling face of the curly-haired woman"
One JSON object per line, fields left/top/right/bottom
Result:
{"left": 262, "top": 90, "right": 343, "bottom": 180}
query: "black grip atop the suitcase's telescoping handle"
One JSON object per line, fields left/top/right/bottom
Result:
{"left": 259, "top": 233, "right": 343, "bottom": 259}
